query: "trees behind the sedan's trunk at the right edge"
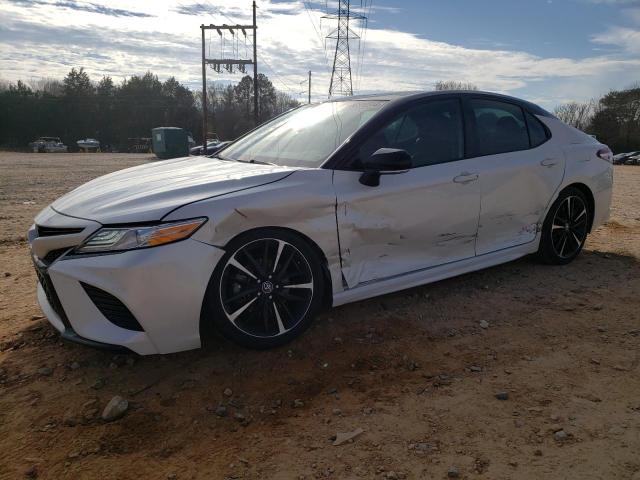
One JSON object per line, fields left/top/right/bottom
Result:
{"left": 554, "top": 84, "right": 640, "bottom": 153}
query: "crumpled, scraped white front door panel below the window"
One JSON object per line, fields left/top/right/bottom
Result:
{"left": 334, "top": 168, "right": 480, "bottom": 288}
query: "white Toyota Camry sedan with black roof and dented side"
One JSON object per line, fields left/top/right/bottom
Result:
{"left": 29, "top": 92, "right": 613, "bottom": 354}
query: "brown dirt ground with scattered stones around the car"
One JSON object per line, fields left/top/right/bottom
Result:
{"left": 0, "top": 153, "right": 640, "bottom": 480}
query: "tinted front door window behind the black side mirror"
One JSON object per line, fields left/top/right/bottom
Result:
{"left": 358, "top": 99, "right": 464, "bottom": 168}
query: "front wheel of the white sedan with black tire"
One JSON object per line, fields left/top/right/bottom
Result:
{"left": 200, "top": 228, "right": 325, "bottom": 349}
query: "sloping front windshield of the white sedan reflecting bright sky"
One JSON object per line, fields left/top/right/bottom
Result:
{"left": 221, "top": 100, "right": 386, "bottom": 168}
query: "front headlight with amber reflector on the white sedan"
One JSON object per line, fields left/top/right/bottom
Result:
{"left": 74, "top": 217, "right": 207, "bottom": 253}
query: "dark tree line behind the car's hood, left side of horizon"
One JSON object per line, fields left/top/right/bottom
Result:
{"left": 0, "top": 68, "right": 298, "bottom": 151}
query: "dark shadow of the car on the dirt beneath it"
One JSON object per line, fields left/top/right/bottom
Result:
{"left": 1, "top": 251, "right": 639, "bottom": 397}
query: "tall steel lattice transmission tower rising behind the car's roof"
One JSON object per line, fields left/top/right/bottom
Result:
{"left": 322, "top": 0, "right": 367, "bottom": 98}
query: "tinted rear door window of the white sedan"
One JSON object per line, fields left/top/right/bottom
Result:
{"left": 470, "top": 99, "right": 529, "bottom": 156}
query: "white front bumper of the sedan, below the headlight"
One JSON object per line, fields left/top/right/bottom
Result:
{"left": 31, "top": 217, "right": 224, "bottom": 355}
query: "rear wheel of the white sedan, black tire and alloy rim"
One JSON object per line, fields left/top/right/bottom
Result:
{"left": 538, "top": 187, "right": 593, "bottom": 265}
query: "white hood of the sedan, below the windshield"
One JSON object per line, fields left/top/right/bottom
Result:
{"left": 51, "top": 157, "right": 295, "bottom": 224}
